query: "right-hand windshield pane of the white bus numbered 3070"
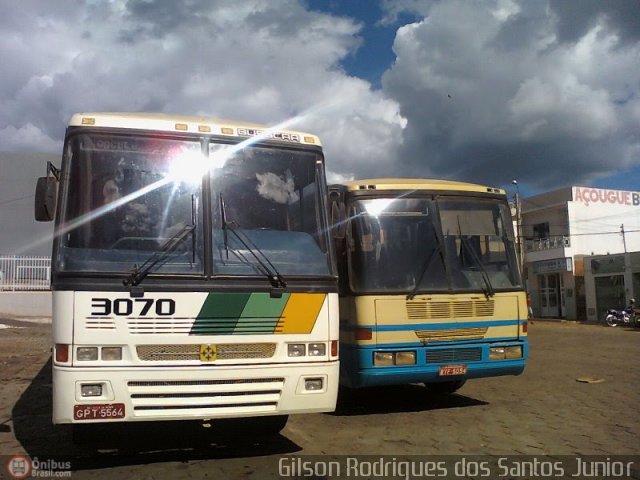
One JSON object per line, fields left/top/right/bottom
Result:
{"left": 209, "top": 145, "right": 330, "bottom": 275}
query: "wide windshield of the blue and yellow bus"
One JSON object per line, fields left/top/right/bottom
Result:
{"left": 347, "top": 197, "right": 521, "bottom": 295}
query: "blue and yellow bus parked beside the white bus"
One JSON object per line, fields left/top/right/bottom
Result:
{"left": 330, "top": 178, "right": 528, "bottom": 393}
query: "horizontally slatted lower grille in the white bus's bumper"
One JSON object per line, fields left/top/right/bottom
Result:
{"left": 127, "top": 378, "right": 284, "bottom": 418}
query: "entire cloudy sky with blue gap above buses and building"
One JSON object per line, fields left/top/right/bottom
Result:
{"left": 0, "top": 0, "right": 640, "bottom": 199}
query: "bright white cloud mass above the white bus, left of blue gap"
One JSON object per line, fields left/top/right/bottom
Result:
{"left": 0, "top": 0, "right": 403, "bottom": 182}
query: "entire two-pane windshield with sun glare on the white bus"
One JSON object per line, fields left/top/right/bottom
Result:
{"left": 54, "top": 133, "right": 331, "bottom": 276}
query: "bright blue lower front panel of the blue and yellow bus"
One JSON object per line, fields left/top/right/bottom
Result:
{"left": 340, "top": 341, "right": 528, "bottom": 388}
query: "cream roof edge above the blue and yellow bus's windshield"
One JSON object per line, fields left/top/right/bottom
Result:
{"left": 341, "top": 178, "right": 506, "bottom": 195}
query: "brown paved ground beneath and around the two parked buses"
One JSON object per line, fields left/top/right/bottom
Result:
{"left": 0, "top": 321, "right": 640, "bottom": 479}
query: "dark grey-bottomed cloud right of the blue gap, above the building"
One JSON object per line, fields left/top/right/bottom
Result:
{"left": 383, "top": 0, "right": 640, "bottom": 188}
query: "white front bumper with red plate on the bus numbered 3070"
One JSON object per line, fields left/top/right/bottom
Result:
{"left": 53, "top": 361, "right": 340, "bottom": 424}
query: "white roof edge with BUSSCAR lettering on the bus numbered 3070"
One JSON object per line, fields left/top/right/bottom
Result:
{"left": 69, "top": 112, "right": 320, "bottom": 146}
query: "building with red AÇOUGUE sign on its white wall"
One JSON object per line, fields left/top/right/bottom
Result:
{"left": 520, "top": 186, "right": 640, "bottom": 321}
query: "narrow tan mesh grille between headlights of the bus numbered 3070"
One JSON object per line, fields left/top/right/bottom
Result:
{"left": 136, "top": 343, "right": 276, "bottom": 362}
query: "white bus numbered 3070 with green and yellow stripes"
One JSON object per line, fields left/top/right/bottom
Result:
{"left": 35, "top": 113, "right": 339, "bottom": 433}
